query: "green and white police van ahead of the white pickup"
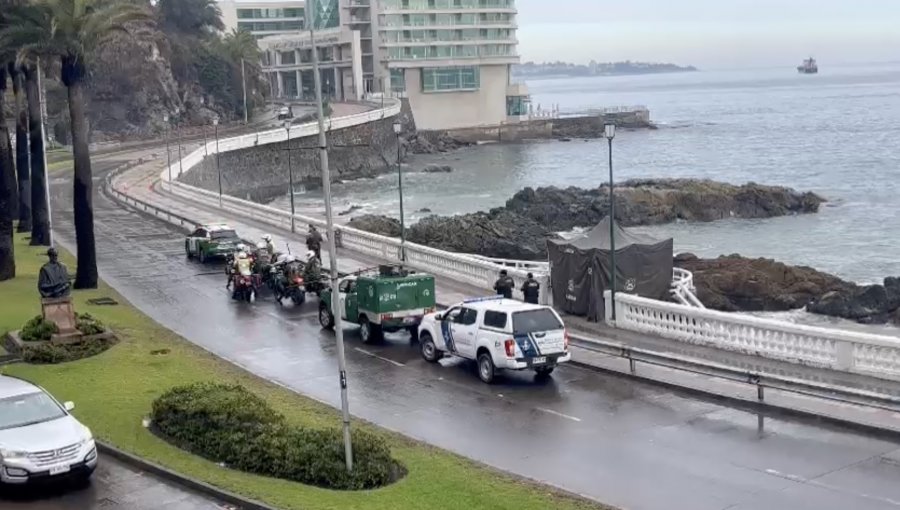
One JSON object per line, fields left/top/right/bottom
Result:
{"left": 319, "top": 265, "right": 435, "bottom": 343}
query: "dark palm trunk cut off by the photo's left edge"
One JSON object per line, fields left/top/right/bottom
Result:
{"left": 0, "top": 63, "right": 17, "bottom": 281}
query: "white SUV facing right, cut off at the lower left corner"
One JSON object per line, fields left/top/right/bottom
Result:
{"left": 0, "top": 375, "right": 97, "bottom": 484}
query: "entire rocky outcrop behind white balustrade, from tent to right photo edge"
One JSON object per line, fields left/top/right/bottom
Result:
{"left": 675, "top": 253, "right": 900, "bottom": 324}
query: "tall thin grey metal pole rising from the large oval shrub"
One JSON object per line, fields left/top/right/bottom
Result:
{"left": 309, "top": 23, "right": 353, "bottom": 471}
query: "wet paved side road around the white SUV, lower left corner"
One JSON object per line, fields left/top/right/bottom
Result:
{"left": 0, "top": 457, "right": 230, "bottom": 510}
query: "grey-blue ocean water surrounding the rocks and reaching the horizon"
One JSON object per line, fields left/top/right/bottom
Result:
{"left": 279, "top": 61, "right": 900, "bottom": 283}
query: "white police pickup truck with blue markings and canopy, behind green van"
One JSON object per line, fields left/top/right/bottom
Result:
{"left": 419, "top": 296, "right": 572, "bottom": 383}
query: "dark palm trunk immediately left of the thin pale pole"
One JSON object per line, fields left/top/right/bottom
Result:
{"left": 23, "top": 64, "right": 50, "bottom": 246}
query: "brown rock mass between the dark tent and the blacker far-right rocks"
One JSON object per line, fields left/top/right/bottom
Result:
{"left": 675, "top": 253, "right": 855, "bottom": 312}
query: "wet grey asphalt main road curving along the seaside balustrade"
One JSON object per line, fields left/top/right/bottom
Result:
{"left": 35, "top": 155, "right": 900, "bottom": 510}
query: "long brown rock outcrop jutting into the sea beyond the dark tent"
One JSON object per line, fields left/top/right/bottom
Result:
{"left": 506, "top": 179, "right": 825, "bottom": 231}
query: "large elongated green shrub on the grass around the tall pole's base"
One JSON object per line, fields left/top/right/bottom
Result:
{"left": 151, "top": 383, "right": 401, "bottom": 490}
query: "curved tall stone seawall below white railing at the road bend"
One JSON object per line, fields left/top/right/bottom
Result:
{"left": 179, "top": 117, "right": 397, "bottom": 202}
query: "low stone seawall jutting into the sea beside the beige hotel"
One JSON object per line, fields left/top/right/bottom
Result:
{"left": 440, "top": 111, "right": 656, "bottom": 143}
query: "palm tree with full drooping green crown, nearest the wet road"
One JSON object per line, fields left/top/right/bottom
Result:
{"left": 0, "top": 0, "right": 152, "bottom": 289}
